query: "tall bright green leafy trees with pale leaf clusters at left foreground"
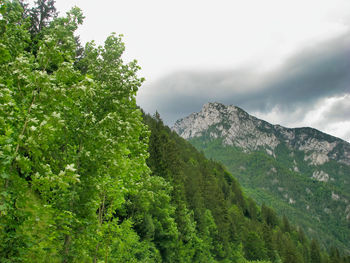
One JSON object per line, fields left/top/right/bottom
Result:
{"left": 0, "top": 1, "right": 150, "bottom": 262}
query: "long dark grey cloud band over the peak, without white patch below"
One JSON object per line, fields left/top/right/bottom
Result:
{"left": 140, "top": 34, "right": 350, "bottom": 124}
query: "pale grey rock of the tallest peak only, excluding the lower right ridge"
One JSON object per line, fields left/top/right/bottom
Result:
{"left": 173, "top": 103, "right": 279, "bottom": 155}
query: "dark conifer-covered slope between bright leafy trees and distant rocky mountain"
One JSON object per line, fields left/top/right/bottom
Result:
{"left": 145, "top": 114, "right": 350, "bottom": 263}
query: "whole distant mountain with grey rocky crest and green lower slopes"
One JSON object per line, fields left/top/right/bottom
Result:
{"left": 173, "top": 103, "right": 350, "bottom": 254}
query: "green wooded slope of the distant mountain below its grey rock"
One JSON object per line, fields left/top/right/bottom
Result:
{"left": 190, "top": 131, "right": 350, "bottom": 253}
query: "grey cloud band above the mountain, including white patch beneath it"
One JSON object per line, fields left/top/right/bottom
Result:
{"left": 139, "top": 32, "right": 350, "bottom": 141}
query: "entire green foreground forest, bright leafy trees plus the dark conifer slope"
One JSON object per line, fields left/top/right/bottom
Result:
{"left": 0, "top": 0, "right": 350, "bottom": 263}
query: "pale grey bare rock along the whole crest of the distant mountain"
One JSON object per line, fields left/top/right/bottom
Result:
{"left": 173, "top": 103, "right": 350, "bottom": 165}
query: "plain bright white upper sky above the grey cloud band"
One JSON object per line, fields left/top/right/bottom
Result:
{"left": 49, "top": 0, "right": 350, "bottom": 81}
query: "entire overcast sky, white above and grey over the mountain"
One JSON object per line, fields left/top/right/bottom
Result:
{"left": 52, "top": 0, "right": 350, "bottom": 141}
